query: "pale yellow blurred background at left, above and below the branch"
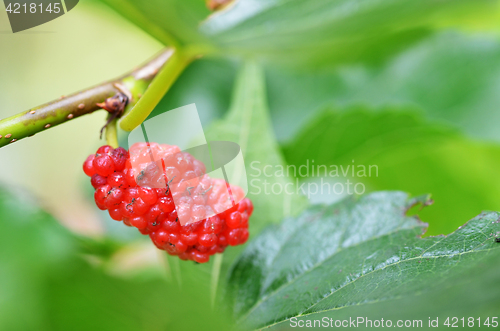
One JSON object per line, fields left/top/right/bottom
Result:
{"left": 0, "top": 1, "right": 161, "bottom": 234}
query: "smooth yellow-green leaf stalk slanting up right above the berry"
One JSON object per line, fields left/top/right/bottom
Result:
{"left": 119, "top": 50, "right": 194, "bottom": 131}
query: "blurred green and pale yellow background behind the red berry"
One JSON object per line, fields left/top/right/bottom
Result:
{"left": 0, "top": 0, "right": 500, "bottom": 330}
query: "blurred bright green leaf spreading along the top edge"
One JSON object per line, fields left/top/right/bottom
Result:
{"left": 96, "top": 0, "right": 499, "bottom": 66}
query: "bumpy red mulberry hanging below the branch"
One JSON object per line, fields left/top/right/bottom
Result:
{"left": 83, "top": 143, "right": 253, "bottom": 263}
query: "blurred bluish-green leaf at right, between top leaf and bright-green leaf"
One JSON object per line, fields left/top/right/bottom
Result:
{"left": 267, "top": 32, "right": 500, "bottom": 141}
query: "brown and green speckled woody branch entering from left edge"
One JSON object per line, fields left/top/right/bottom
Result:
{"left": 0, "top": 48, "right": 175, "bottom": 147}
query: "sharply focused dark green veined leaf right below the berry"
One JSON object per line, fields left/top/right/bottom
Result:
{"left": 228, "top": 192, "right": 500, "bottom": 328}
